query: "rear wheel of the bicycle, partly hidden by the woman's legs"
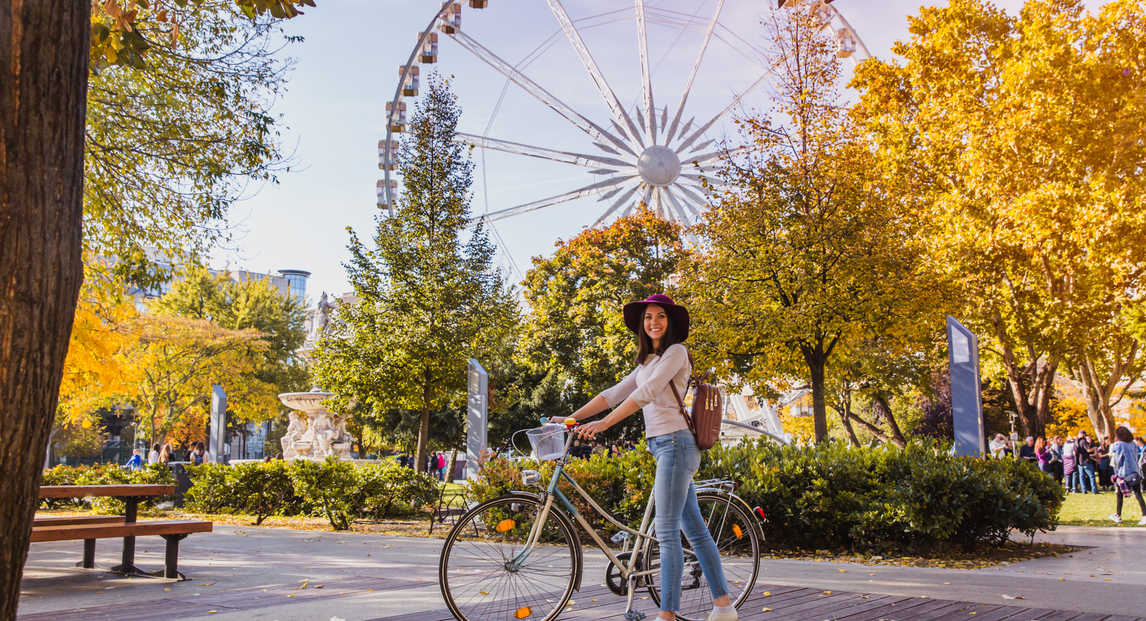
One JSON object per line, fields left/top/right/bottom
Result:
{"left": 645, "top": 492, "right": 763, "bottom": 621}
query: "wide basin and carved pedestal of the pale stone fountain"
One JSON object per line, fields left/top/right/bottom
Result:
{"left": 278, "top": 388, "right": 354, "bottom": 459}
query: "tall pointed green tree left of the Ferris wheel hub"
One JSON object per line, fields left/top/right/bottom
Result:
{"left": 314, "top": 76, "right": 517, "bottom": 470}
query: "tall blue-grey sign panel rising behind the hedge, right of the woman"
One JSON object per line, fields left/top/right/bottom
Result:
{"left": 947, "top": 316, "right": 987, "bottom": 457}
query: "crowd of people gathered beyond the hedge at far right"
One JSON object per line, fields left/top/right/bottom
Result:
{"left": 990, "top": 426, "right": 1146, "bottom": 526}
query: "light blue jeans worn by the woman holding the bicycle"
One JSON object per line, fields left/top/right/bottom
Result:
{"left": 649, "top": 430, "right": 728, "bottom": 612}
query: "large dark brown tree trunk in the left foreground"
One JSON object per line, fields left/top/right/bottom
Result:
{"left": 0, "top": 0, "right": 91, "bottom": 621}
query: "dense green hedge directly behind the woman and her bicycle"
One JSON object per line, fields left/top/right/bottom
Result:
{"left": 471, "top": 440, "right": 1063, "bottom": 550}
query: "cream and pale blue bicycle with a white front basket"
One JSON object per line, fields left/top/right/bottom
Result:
{"left": 438, "top": 419, "right": 763, "bottom": 621}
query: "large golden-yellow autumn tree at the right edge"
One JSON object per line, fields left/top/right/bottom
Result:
{"left": 853, "top": 0, "right": 1146, "bottom": 435}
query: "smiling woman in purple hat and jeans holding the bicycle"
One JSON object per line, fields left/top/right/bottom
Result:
{"left": 573, "top": 293, "right": 738, "bottom": 621}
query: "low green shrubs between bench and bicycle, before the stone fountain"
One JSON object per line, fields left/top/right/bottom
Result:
{"left": 187, "top": 459, "right": 438, "bottom": 530}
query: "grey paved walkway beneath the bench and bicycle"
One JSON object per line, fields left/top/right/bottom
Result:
{"left": 19, "top": 526, "right": 1146, "bottom": 621}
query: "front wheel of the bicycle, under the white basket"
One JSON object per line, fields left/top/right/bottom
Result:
{"left": 438, "top": 495, "right": 579, "bottom": 621}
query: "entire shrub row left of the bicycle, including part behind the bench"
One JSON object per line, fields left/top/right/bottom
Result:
{"left": 40, "top": 459, "right": 438, "bottom": 530}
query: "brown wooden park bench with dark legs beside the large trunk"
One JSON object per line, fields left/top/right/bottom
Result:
{"left": 32, "top": 485, "right": 212, "bottom": 580}
